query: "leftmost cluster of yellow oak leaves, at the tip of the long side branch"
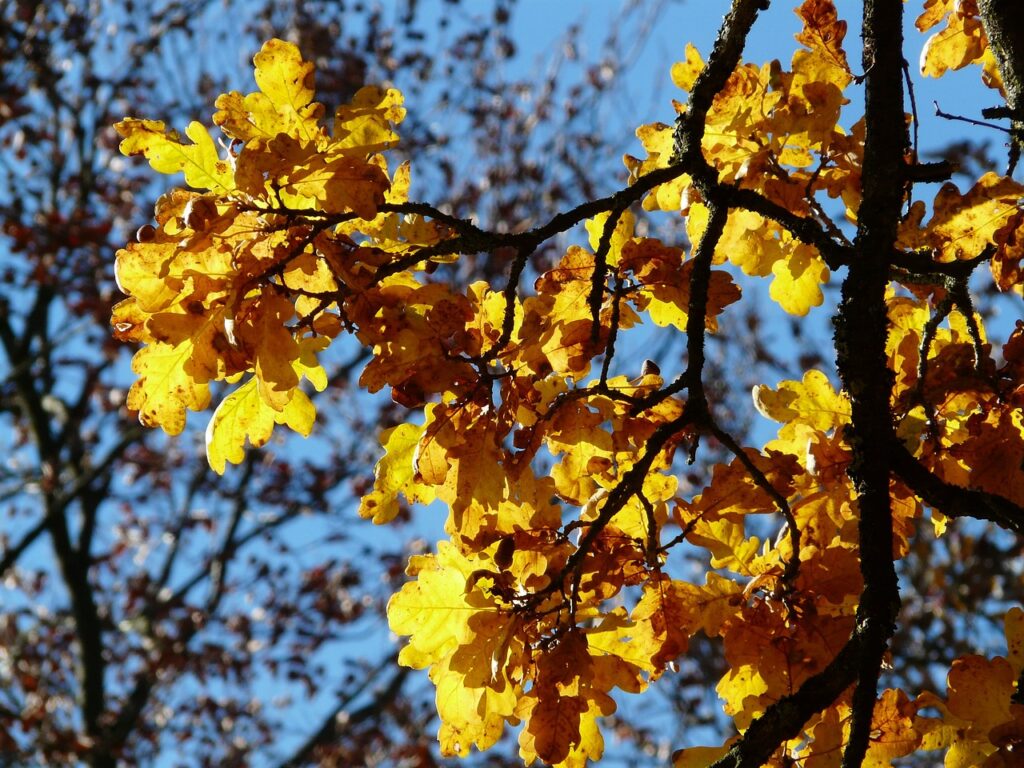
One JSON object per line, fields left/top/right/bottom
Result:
{"left": 113, "top": 42, "right": 411, "bottom": 460}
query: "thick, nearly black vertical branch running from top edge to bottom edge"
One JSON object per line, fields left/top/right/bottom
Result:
{"left": 836, "top": 0, "right": 908, "bottom": 768}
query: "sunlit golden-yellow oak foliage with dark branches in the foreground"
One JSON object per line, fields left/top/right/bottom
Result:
{"left": 113, "top": 0, "right": 1024, "bottom": 766}
